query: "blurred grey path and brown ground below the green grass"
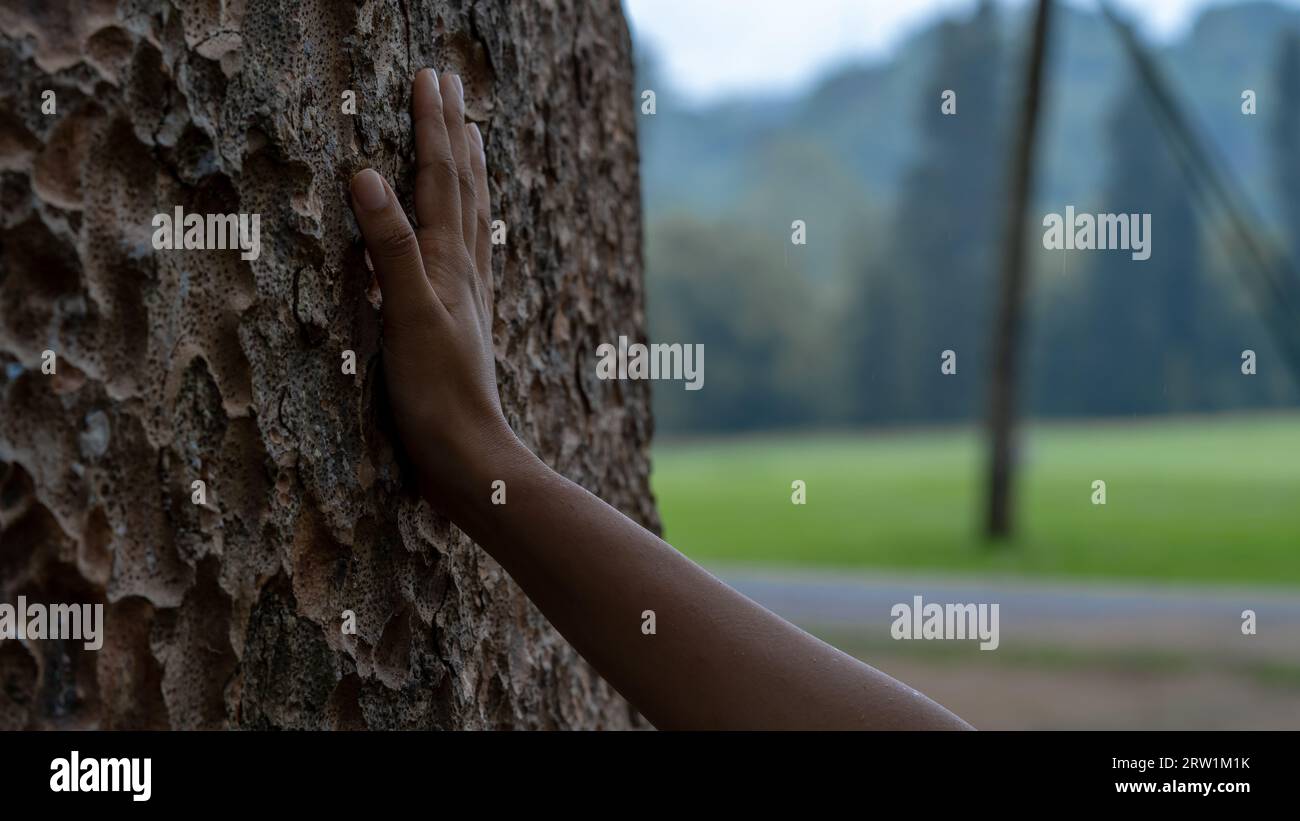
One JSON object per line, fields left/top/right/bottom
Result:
{"left": 712, "top": 566, "right": 1300, "bottom": 729}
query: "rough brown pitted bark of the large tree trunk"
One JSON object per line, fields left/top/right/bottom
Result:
{"left": 0, "top": 0, "right": 658, "bottom": 729}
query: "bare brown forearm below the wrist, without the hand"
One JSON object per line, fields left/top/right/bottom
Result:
{"left": 441, "top": 436, "right": 967, "bottom": 729}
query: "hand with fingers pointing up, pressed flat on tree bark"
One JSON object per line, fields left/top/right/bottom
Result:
{"left": 351, "top": 69, "right": 517, "bottom": 512}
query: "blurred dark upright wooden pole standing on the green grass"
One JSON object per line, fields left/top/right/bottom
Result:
{"left": 987, "top": 0, "right": 1052, "bottom": 538}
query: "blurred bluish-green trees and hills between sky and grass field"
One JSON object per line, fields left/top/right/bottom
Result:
{"left": 638, "top": 3, "right": 1300, "bottom": 433}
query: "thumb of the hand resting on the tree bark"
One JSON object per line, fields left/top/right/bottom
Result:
{"left": 351, "top": 169, "right": 441, "bottom": 327}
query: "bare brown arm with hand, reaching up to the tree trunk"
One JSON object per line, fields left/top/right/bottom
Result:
{"left": 352, "top": 69, "right": 969, "bottom": 729}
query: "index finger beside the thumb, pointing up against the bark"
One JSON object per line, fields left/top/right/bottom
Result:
{"left": 411, "top": 69, "right": 462, "bottom": 236}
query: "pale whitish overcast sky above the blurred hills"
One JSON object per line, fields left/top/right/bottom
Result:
{"left": 623, "top": 0, "right": 1300, "bottom": 103}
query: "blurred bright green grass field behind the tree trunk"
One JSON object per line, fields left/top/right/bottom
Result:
{"left": 653, "top": 416, "right": 1300, "bottom": 586}
